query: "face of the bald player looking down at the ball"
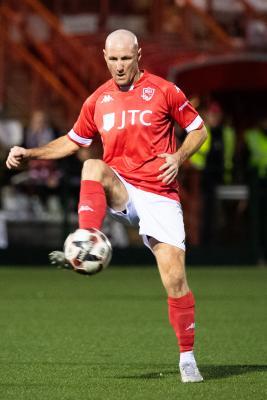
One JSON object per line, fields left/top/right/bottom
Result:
{"left": 104, "top": 44, "right": 141, "bottom": 86}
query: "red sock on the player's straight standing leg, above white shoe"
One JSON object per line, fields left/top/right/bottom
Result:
{"left": 168, "top": 292, "right": 195, "bottom": 352}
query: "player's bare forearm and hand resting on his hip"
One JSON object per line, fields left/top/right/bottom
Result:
{"left": 158, "top": 126, "right": 208, "bottom": 184}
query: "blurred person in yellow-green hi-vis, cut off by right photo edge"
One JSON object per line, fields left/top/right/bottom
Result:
{"left": 244, "top": 117, "right": 267, "bottom": 264}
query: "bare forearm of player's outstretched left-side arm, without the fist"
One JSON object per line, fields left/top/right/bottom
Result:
{"left": 25, "top": 135, "right": 79, "bottom": 160}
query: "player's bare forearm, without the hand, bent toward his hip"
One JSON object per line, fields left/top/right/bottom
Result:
{"left": 176, "top": 126, "right": 208, "bottom": 165}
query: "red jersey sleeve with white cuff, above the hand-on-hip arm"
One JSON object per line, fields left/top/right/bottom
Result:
{"left": 167, "top": 85, "right": 203, "bottom": 133}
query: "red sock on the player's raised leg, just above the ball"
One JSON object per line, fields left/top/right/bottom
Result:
{"left": 78, "top": 180, "right": 107, "bottom": 229}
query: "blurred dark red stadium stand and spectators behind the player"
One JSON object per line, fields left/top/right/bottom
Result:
{"left": 0, "top": 0, "right": 267, "bottom": 265}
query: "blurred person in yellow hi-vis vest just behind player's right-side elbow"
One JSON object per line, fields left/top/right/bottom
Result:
{"left": 190, "top": 102, "right": 236, "bottom": 243}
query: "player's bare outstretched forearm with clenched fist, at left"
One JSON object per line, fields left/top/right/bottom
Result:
{"left": 6, "top": 135, "right": 79, "bottom": 169}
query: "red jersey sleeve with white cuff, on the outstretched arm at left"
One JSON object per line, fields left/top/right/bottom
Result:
{"left": 68, "top": 95, "right": 98, "bottom": 147}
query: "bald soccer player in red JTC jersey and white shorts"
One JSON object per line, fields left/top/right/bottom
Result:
{"left": 6, "top": 30, "right": 207, "bottom": 382}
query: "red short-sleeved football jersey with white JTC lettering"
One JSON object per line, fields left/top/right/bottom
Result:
{"left": 68, "top": 71, "right": 203, "bottom": 200}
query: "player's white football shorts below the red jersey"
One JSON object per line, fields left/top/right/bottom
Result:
{"left": 108, "top": 171, "right": 185, "bottom": 250}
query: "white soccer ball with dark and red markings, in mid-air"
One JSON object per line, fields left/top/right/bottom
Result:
{"left": 64, "top": 228, "right": 112, "bottom": 275}
